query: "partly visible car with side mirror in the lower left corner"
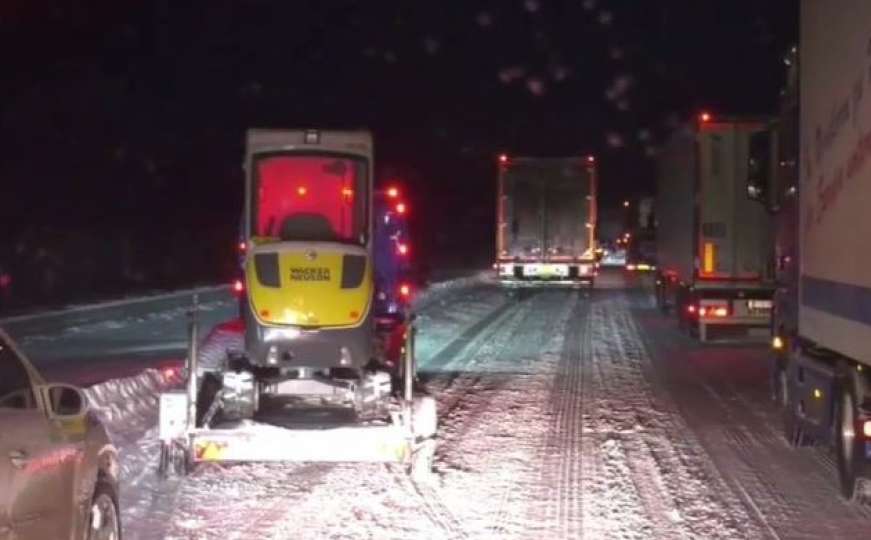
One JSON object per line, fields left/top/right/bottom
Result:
{"left": 0, "top": 329, "right": 121, "bottom": 540}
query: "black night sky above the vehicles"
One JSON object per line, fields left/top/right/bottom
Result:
{"left": 0, "top": 0, "right": 798, "bottom": 264}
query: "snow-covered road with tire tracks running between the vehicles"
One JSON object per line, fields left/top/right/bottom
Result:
{"left": 6, "top": 272, "right": 871, "bottom": 539}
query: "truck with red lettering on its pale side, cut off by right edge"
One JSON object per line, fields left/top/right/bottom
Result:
{"left": 747, "top": 0, "right": 871, "bottom": 498}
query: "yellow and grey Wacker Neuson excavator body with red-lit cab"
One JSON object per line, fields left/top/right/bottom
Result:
{"left": 242, "top": 130, "right": 374, "bottom": 370}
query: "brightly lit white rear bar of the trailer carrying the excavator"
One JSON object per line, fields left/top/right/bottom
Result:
{"left": 191, "top": 425, "right": 416, "bottom": 463}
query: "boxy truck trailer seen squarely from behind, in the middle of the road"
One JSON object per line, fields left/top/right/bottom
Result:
{"left": 495, "top": 155, "right": 597, "bottom": 287}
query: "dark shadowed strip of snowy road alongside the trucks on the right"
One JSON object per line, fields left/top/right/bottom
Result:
{"left": 636, "top": 293, "right": 871, "bottom": 538}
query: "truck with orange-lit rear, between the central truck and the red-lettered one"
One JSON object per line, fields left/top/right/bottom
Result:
{"left": 655, "top": 113, "right": 773, "bottom": 342}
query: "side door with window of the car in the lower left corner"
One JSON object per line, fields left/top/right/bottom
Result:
{"left": 0, "top": 336, "right": 75, "bottom": 539}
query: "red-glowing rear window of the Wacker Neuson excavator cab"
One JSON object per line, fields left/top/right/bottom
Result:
{"left": 251, "top": 154, "right": 368, "bottom": 244}
